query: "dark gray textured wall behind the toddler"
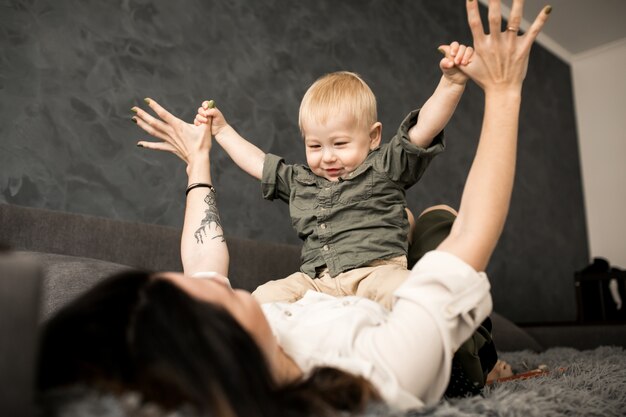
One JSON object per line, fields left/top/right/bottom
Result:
{"left": 0, "top": 0, "right": 588, "bottom": 322}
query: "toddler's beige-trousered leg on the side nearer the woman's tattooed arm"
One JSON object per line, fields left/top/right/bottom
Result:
{"left": 252, "top": 272, "right": 320, "bottom": 304}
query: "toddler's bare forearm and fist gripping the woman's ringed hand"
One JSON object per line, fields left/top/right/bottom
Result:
{"left": 409, "top": 42, "right": 474, "bottom": 148}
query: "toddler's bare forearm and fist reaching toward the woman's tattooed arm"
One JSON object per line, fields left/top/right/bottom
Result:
{"left": 194, "top": 100, "right": 265, "bottom": 180}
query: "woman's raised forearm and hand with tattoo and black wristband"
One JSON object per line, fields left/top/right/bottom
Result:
{"left": 133, "top": 99, "right": 229, "bottom": 276}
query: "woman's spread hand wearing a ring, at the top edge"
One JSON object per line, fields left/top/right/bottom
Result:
{"left": 443, "top": 0, "right": 552, "bottom": 93}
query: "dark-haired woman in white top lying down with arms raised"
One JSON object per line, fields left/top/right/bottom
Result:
{"left": 38, "top": 0, "right": 550, "bottom": 417}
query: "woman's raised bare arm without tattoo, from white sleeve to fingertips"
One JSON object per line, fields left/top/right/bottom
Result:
{"left": 438, "top": 0, "right": 552, "bottom": 271}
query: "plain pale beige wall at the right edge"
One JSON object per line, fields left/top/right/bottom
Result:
{"left": 571, "top": 40, "right": 626, "bottom": 268}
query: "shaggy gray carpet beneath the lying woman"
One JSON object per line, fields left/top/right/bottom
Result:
{"left": 44, "top": 347, "right": 626, "bottom": 417}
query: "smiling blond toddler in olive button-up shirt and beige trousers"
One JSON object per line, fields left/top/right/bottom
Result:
{"left": 195, "top": 42, "right": 473, "bottom": 307}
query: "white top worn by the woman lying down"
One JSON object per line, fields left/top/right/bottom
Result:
{"left": 262, "top": 251, "right": 492, "bottom": 409}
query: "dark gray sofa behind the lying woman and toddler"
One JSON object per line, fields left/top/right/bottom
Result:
{"left": 0, "top": 204, "right": 584, "bottom": 416}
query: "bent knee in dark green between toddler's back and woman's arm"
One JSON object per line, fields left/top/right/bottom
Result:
{"left": 407, "top": 204, "right": 457, "bottom": 269}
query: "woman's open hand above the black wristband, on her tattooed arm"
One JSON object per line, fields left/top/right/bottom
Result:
{"left": 132, "top": 98, "right": 211, "bottom": 164}
